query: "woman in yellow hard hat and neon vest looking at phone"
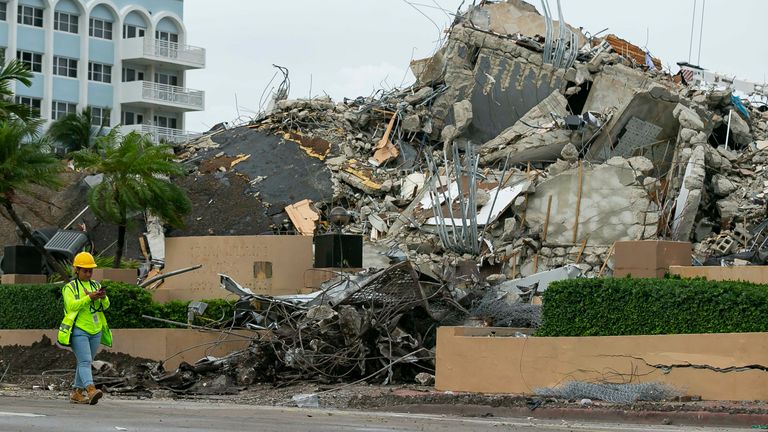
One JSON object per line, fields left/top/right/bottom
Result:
{"left": 57, "top": 252, "right": 112, "bottom": 405}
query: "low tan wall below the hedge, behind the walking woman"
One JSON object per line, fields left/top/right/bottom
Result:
{"left": 0, "top": 329, "right": 251, "bottom": 370}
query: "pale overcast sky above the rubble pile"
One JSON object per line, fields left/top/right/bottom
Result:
{"left": 184, "top": 0, "right": 768, "bottom": 131}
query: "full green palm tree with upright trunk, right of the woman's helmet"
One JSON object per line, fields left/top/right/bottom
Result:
{"left": 72, "top": 128, "right": 192, "bottom": 268}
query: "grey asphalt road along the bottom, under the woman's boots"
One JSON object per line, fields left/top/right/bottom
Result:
{"left": 0, "top": 397, "right": 743, "bottom": 432}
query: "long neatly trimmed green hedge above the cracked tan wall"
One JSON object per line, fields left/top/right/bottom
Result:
{"left": 536, "top": 278, "right": 768, "bottom": 336}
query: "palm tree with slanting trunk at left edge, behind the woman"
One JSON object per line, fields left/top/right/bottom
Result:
{"left": 0, "top": 118, "right": 68, "bottom": 279}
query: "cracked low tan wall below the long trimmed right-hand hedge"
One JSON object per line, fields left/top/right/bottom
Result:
{"left": 435, "top": 327, "right": 768, "bottom": 401}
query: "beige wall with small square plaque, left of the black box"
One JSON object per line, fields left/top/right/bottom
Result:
{"left": 152, "top": 236, "right": 313, "bottom": 302}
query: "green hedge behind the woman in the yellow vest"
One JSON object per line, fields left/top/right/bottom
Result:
{"left": 0, "top": 281, "right": 234, "bottom": 329}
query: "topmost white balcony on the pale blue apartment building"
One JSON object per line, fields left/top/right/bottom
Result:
{"left": 122, "top": 37, "right": 205, "bottom": 69}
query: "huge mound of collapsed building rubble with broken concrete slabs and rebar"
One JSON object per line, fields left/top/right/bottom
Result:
{"left": 172, "top": 1, "right": 768, "bottom": 279}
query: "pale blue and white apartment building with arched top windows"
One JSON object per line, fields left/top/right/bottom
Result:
{"left": 0, "top": 0, "right": 205, "bottom": 141}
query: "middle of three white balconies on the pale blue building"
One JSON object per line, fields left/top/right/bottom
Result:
{"left": 120, "top": 81, "right": 205, "bottom": 111}
